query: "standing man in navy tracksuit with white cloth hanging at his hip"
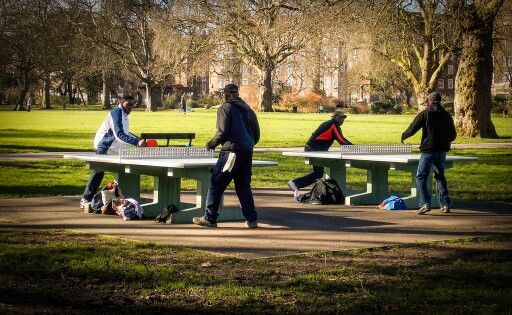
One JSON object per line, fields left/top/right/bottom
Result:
{"left": 192, "top": 84, "right": 260, "bottom": 228}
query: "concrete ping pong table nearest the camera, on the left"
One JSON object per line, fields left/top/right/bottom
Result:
{"left": 64, "top": 147, "right": 277, "bottom": 223}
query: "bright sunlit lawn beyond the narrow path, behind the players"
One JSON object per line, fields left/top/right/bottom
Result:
{"left": 0, "top": 109, "right": 512, "bottom": 152}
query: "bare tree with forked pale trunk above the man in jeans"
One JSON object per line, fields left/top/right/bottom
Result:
{"left": 373, "top": 0, "right": 457, "bottom": 110}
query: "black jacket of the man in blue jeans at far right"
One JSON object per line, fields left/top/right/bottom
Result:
{"left": 402, "top": 105, "right": 457, "bottom": 152}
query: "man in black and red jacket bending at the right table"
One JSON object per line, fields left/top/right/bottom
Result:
{"left": 288, "top": 109, "right": 352, "bottom": 201}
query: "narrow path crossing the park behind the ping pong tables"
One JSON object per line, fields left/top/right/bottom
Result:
{"left": 0, "top": 142, "right": 512, "bottom": 161}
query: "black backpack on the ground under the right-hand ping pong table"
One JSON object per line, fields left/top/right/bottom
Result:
{"left": 298, "top": 178, "right": 345, "bottom": 205}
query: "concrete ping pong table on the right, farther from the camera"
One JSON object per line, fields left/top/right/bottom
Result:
{"left": 282, "top": 145, "right": 477, "bottom": 209}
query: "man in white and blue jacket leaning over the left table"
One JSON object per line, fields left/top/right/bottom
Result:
{"left": 80, "top": 95, "right": 146, "bottom": 209}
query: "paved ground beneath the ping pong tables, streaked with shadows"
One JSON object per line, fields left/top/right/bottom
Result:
{"left": 0, "top": 189, "right": 512, "bottom": 258}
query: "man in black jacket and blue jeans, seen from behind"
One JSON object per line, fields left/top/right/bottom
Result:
{"left": 401, "top": 92, "right": 457, "bottom": 214}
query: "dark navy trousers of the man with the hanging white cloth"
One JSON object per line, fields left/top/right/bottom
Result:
{"left": 204, "top": 151, "right": 258, "bottom": 223}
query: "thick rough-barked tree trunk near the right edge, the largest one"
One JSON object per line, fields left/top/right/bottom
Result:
{"left": 455, "top": 15, "right": 498, "bottom": 138}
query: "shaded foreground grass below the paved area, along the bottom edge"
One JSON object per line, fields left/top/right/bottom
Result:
{"left": 0, "top": 231, "right": 512, "bottom": 314}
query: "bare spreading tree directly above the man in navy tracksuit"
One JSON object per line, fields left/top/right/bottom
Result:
{"left": 202, "top": 0, "right": 310, "bottom": 111}
